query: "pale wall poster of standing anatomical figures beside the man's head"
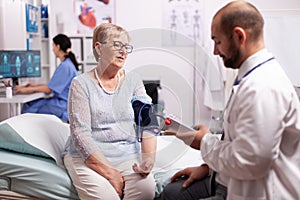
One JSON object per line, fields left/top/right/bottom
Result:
{"left": 162, "top": 0, "right": 204, "bottom": 46}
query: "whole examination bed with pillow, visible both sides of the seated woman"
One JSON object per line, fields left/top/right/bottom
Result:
{"left": 0, "top": 114, "right": 202, "bottom": 200}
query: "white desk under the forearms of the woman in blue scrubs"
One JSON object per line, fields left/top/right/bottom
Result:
{"left": 0, "top": 92, "right": 46, "bottom": 117}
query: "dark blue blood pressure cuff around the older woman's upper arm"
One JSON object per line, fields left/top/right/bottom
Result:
{"left": 132, "top": 100, "right": 158, "bottom": 127}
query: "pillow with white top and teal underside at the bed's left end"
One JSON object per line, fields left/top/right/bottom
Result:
{"left": 0, "top": 113, "right": 70, "bottom": 166}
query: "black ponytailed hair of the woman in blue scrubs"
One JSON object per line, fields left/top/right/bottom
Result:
{"left": 52, "top": 34, "right": 79, "bottom": 71}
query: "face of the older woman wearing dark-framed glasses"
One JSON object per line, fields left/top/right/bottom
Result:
{"left": 99, "top": 34, "right": 130, "bottom": 71}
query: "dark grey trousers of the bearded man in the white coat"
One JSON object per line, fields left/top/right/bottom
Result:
{"left": 160, "top": 176, "right": 227, "bottom": 200}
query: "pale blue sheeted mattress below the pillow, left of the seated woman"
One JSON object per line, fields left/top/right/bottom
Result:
{"left": 0, "top": 149, "right": 79, "bottom": 200}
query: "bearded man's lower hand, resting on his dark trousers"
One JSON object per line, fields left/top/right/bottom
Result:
{"left": 171, "top": 164, "right": 209, "bottom": 188}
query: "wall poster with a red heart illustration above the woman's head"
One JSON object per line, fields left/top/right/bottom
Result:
{"left": 73, "top": 0, "right": 115, "bottom": 35}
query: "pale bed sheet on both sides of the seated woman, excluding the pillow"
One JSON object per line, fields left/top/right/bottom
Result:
{"left": 0, "top": 136, "right": 203, "bottom": 200}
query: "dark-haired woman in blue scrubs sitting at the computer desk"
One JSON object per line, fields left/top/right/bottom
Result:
{"left": 15, "top": 34, "right": 78, "bottom": 122}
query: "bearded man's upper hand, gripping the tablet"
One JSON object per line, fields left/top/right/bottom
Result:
{"left": 176, "top": 125, "right": 209, "bottom": 150}
